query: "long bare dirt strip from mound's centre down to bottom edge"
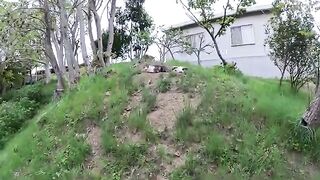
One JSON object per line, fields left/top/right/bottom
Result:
{"left": 147, "top": 90, "right": 201, "bottom": 179}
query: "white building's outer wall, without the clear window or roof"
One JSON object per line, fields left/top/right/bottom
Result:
{"left": 167, "top": 13, "right": 280, "bottom": 78}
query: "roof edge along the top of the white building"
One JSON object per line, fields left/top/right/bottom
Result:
{"left": 166, "top": 4, "right": 272, "bottom": 30}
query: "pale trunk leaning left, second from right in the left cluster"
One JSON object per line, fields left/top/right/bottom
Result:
{"left": 89, "top": 0, "right": 106, "bottom": 67}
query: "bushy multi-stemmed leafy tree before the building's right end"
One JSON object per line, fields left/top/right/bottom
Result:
{"left": 267, "top": 0, "right": 317, "bottom": 90}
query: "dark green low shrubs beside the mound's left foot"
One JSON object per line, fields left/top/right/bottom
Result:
{"left": 0, "top": 82, "right": 55, "bottom": 149}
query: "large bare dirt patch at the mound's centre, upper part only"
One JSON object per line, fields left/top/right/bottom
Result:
{"left": 147, "top": 91, "right": 200, "bottom": 132}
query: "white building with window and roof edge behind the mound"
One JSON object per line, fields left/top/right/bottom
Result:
{"left": 166, "top": 5, "right": 280, "bottom": 78}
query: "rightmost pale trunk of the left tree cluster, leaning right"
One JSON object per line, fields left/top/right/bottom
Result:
{"left": 106, "top": 0, "right": 117, "bottom": 64}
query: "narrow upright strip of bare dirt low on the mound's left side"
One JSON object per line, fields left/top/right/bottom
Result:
{"left": 85, "top": 122, "right": 103, "bottom": 171}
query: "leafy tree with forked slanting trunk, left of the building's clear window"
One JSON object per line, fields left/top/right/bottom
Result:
{"left": 177, "top": 0, "right": 255, "bottom": 66}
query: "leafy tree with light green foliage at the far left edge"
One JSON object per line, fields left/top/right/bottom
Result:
{"left": 0, "top": 1, "right": 46, "bottom": 93}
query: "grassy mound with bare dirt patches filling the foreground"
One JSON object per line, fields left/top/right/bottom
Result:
{"left": 0, "top": 62, "right": 320, "bottom": 179}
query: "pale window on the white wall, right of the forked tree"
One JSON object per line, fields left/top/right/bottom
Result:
{"left": 231, "top": 24, "right": 255, "bottom": 46}
